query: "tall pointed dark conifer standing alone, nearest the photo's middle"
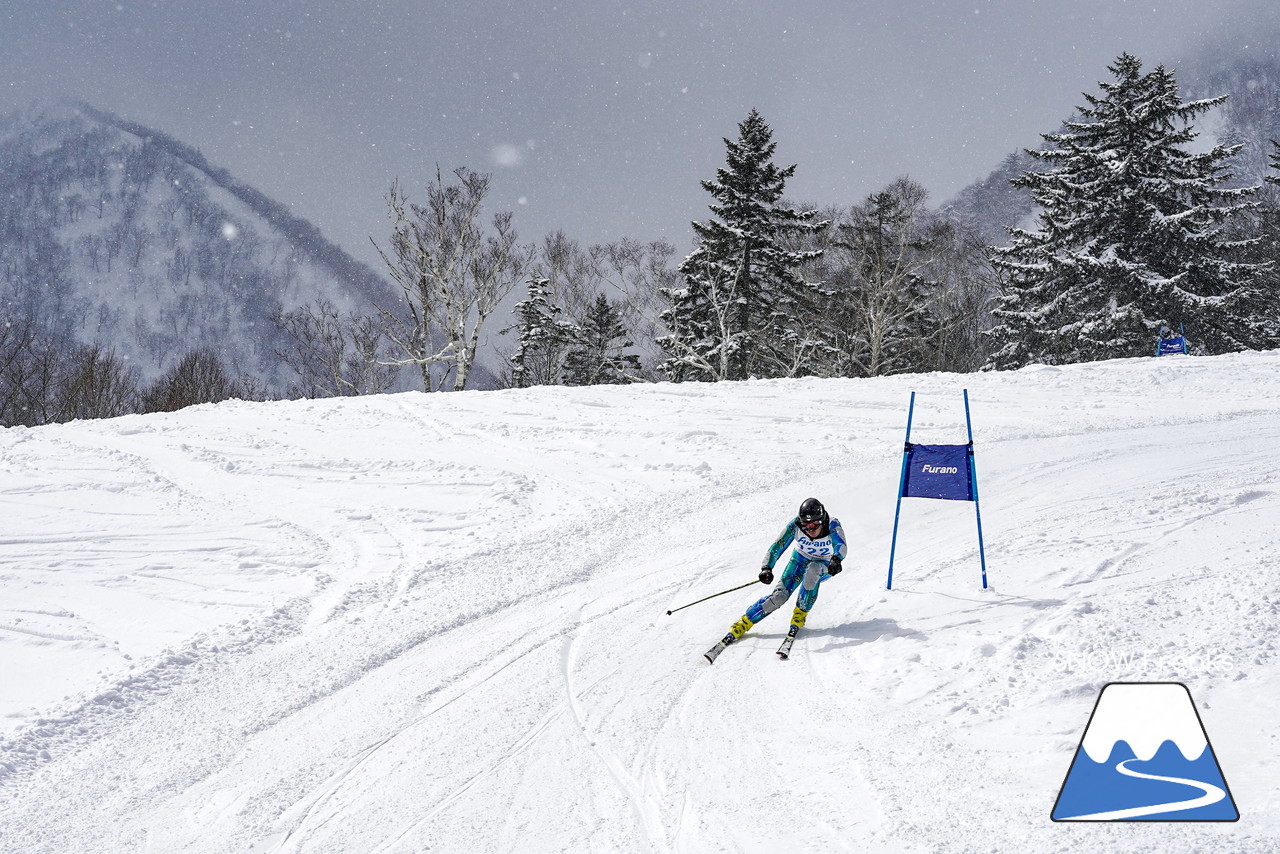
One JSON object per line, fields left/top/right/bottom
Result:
{"left": 658, "top": 109, "right": 826, "bottom": 380}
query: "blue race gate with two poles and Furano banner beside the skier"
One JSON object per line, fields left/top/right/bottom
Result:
{"left": 886, "top": 389, "right": 987, "bottom": 590}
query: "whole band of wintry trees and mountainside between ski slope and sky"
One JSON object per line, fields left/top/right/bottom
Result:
{"left": 0, "top": 55, "right": 1280, "bottom": 425}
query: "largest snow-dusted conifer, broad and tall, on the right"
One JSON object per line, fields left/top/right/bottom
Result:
{"left": 988, "top": 54, "right": 1274, "bottom": 367}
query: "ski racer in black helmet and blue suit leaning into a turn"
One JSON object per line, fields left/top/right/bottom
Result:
{"left": 707, "top": 498, "right": 849, "bottom": 662}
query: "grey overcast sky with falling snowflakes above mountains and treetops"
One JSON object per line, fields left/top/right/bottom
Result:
{"left": 0, "top": 0, "right": 1280, "bottom": 265}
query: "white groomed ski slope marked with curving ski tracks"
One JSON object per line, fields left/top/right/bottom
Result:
{"left": 0, "top": 352, "right": 1280, "bottom": 854}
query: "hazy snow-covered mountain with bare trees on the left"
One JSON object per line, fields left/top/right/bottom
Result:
{"left": 0, "top": 105, "right": 397, "bottom": 423}
